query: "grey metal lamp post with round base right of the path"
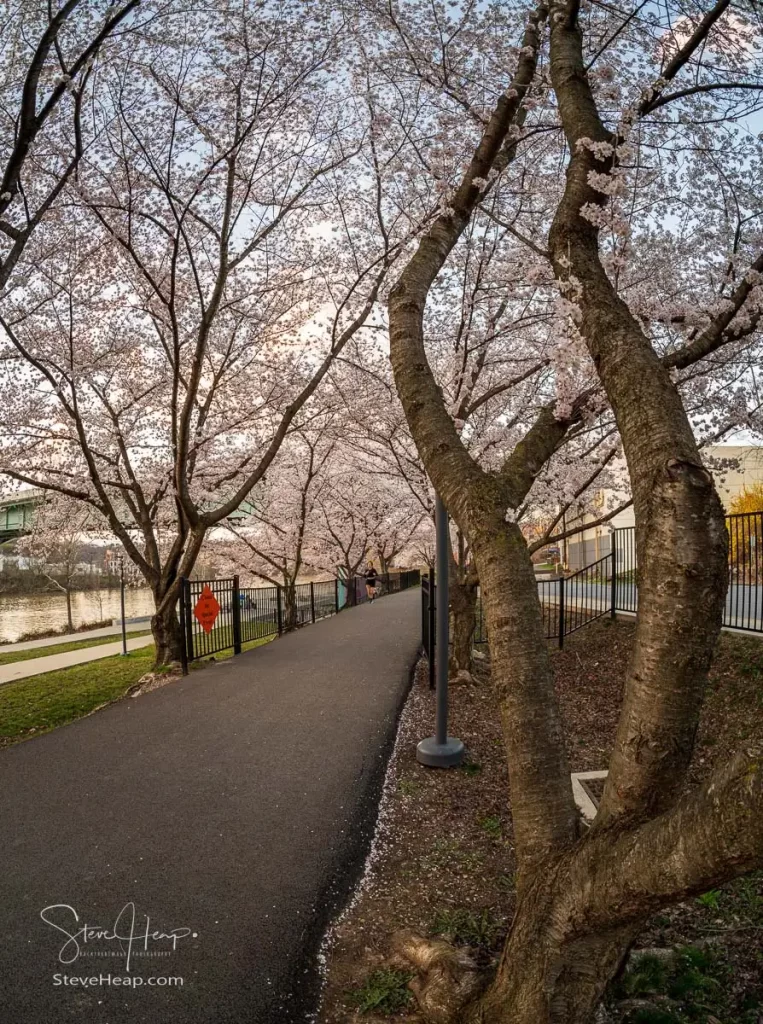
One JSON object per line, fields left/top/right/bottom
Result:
{"left": 416, "top": 495, "right": 464, "bottom": 768}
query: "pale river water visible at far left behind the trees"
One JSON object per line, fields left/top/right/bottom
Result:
{"left": 0, "top": 590, "right": 154, "bottom": 642}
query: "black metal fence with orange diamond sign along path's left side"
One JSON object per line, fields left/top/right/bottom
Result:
{"left": 179, "top": 569, "right": 420, "bottom": 672}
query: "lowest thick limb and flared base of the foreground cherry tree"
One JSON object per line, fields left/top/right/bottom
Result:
{"left": 397, "top": 741, "right": 763, "bottom": 1024}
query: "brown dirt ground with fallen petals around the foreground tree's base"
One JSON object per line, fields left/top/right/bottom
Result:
{"left": 319, "top": 620, "right": 763, "bottom": 1024}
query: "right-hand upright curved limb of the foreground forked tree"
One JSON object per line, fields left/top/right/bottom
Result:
{"left": 549, "top": 4, "right": 728, "bottom": 826}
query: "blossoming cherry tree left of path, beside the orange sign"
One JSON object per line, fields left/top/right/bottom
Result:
{"left": 0, "top": 3, "right": 410, "bottom": 664}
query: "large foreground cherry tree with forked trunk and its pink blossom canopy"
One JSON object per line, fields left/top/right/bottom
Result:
{"left": 356, "top": 0, "right": 763, "bottom": 1024}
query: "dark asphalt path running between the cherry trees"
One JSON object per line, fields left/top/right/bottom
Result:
{"left": 0, "top": 590, "right": 420, "bottom": 1024}
